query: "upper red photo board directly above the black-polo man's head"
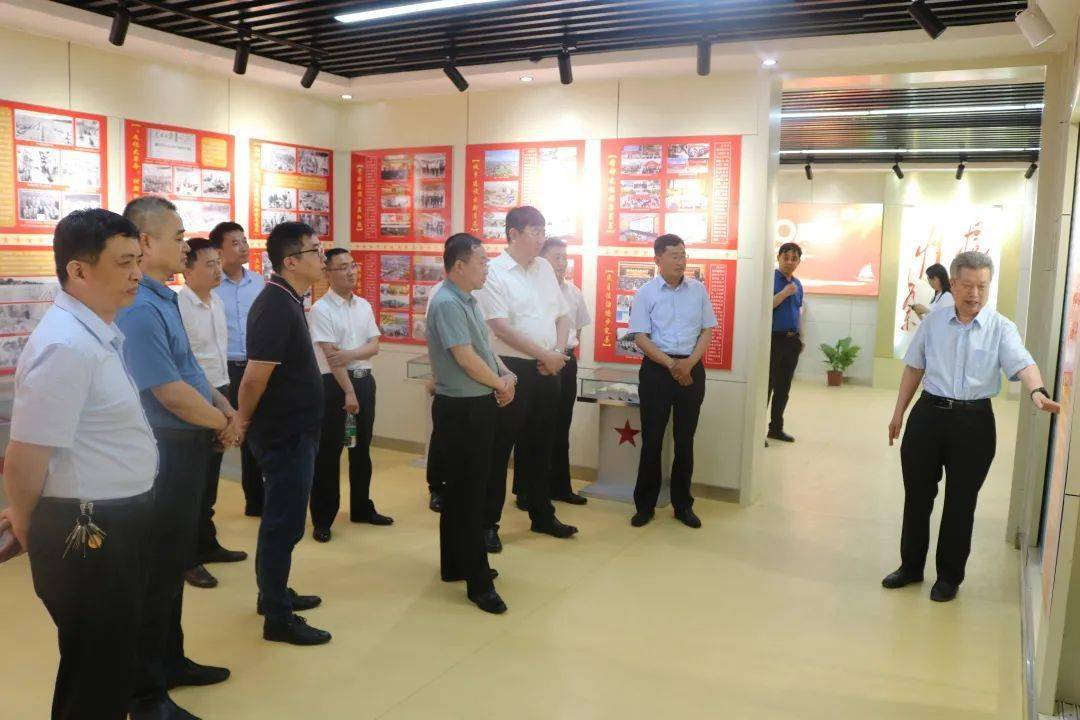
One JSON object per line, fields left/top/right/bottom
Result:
{"left": 247, "top": 140, "right": 334, "bottom": 241}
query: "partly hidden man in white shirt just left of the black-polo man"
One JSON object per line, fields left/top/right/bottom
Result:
{"left": 177, "top": 237, "right": 247, "bottom": 587}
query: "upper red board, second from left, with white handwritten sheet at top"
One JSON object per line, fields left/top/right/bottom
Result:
{"left": 124, "top": 120, "right": 236, "bottom": 235}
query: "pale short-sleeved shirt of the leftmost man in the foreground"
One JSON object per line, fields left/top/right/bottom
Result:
{"left": 11, "top": 290, "right": 158, "bottom": 501}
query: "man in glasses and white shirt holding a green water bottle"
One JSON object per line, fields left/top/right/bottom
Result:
{"left": 308, "top": 247, "right": 393, "bottom": 543}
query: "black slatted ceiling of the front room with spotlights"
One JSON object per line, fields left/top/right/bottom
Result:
{"left": 54, "top": 0, "right": 1027, "bottom": 78}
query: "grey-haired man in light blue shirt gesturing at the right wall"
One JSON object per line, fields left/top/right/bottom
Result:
{"left": 881, "top": 252, "right": 1058, "bottom": 602}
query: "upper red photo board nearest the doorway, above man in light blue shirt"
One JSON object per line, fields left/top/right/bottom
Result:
{"left": 600, "top": 135, "right": 742, "bottom": 250}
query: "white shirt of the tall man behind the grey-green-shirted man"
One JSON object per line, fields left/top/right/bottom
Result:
{"left": 473, "top": 250, "right": 570, "bottom": 358}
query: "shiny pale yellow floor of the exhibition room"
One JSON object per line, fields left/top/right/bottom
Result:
{"left": 0, "top": 384, "right": 1022, "bottom": 720}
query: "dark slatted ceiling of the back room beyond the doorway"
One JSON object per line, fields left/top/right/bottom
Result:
{"left": 780, "top": 83, "right": 1043, "bottom": 164}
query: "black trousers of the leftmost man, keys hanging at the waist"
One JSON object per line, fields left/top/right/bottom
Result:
{"left": 29, "top": 493, "right": 151, "bottom": 720}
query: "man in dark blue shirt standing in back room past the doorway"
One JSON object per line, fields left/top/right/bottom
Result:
{"left": 767, "top": 243, "right": 804, "bottom": 443}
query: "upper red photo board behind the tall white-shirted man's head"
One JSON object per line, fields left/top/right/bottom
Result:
{"left": 465, "top": 140, "right": 585, "bottom": 245}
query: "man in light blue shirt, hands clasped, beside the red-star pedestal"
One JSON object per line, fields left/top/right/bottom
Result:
{"left": 629, "top": 234, "right": 716, "bottom": 528}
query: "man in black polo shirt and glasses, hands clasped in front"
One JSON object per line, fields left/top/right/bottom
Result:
{"left": 239, "top": 222, "right": 330, "bottom": 644}
